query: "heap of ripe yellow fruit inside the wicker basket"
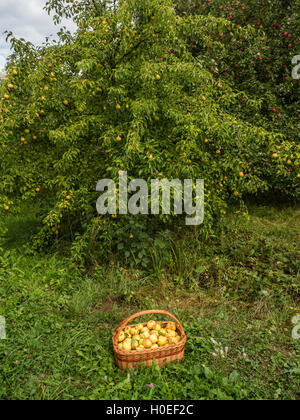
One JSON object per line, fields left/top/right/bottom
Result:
{"left": 118, "top": 320, "right": 181, "bottom": 351}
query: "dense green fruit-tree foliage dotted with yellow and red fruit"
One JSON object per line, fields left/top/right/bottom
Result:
{"left": 0, "top": 0, "right": 300, "bottom": 265}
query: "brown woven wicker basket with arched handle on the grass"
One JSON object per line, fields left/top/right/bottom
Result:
{"left": 112, "top": 310, "right": 186, "bottom": 370}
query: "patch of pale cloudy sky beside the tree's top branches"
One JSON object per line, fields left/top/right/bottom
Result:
{"left": 0, "top": 0, "right": 75, "bottom": 69}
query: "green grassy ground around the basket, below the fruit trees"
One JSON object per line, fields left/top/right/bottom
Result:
{"left": 0, "top": 206, "right": 300, "bottom": 400}
